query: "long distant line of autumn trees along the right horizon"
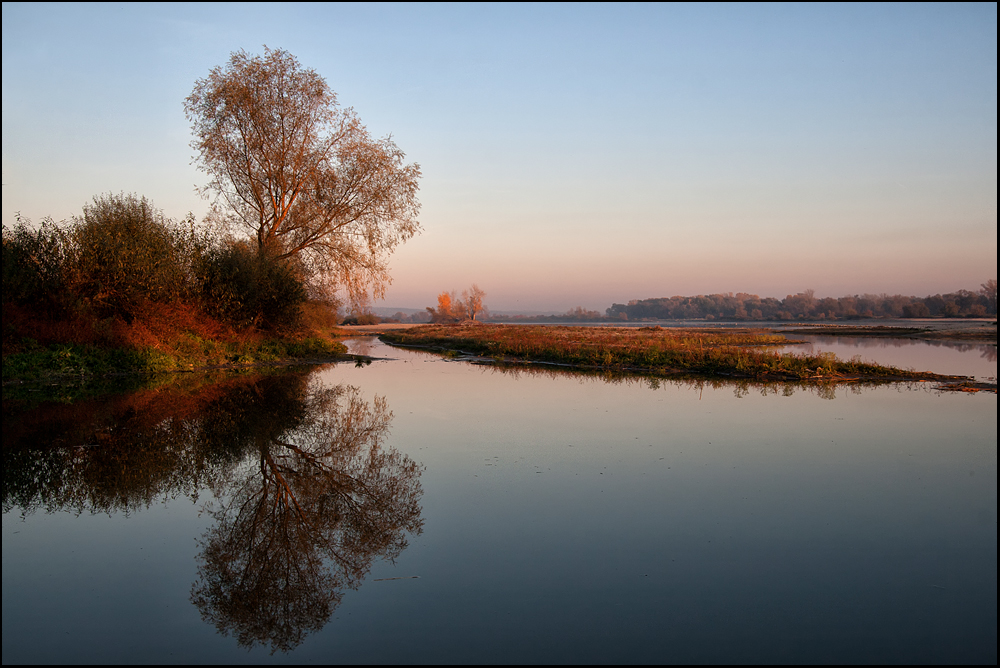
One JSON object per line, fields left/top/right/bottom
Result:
{"left": 605, "top": 279, "right": 997, "bottom": 321}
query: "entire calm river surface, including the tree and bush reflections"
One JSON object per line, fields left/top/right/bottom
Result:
{"left": 3, "top": 340, "right": 997, "bottom": 664}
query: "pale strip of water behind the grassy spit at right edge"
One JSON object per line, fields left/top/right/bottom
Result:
{"left": 786, "top": 334, "right": 997, "bottom": 380}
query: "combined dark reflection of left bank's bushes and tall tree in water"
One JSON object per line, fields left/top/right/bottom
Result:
{"left": 3, "top": 371, "right": 423, "bottom": 652}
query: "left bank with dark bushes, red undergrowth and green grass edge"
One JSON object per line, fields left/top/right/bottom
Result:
{"left": 2, "top": 193, "right": 354, "bottom": 384}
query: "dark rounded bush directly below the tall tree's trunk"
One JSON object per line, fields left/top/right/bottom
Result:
{"left": 198, "top": 244, "right": 306, "bottom": 329}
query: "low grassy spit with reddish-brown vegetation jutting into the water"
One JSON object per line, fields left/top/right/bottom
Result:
{"left": 382, "top": 324, "right": 960, "bottom": 380}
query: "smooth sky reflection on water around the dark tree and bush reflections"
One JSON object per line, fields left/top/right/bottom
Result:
{"left": 3, "top": 343, "right": 997, "bottom": 663}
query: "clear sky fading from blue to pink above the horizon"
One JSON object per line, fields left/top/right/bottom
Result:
{"left": 2, "top": 3, "right": 997, "bottom": 312}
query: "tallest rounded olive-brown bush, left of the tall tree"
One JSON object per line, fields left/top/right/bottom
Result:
{"left": 73, "top": 194, "right": 186, "bottom": 320}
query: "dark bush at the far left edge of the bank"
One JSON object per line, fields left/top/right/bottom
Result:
{"left": 3, "top": 214, "right": 68, "bottom": 308}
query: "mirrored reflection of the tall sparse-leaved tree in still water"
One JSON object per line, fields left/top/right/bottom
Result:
{"left": 191, "top": 386, "right": 422, "bottom": 652}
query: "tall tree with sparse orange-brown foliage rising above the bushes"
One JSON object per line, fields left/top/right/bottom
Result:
{"left": 184, "top": 47, "right": 420, "bottom": 306}
